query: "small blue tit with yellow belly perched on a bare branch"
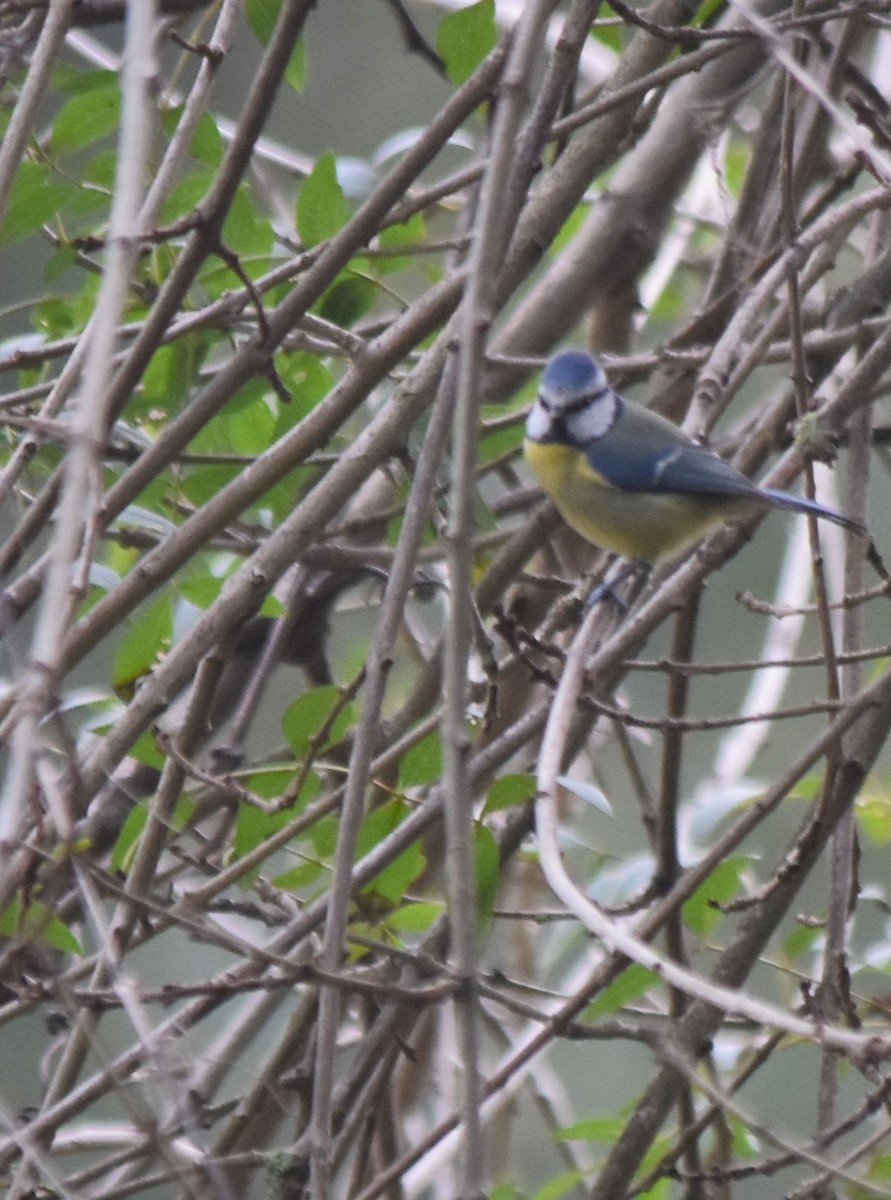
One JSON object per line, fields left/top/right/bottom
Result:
{"left": 524, "top": 350, "right": 866, "bottom": 562}
